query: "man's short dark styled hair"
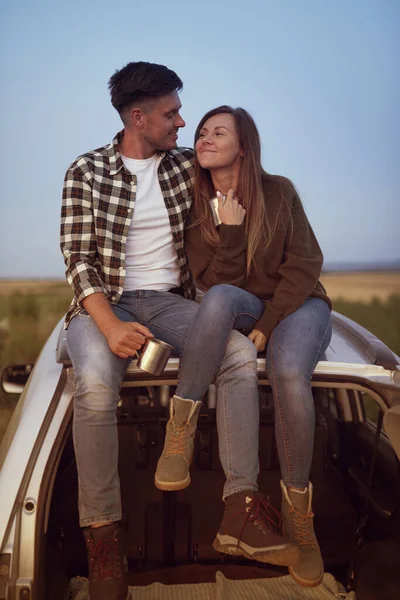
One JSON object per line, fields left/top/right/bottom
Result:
{"left": 108, "top": 62, "right": 183, "bottom": 117}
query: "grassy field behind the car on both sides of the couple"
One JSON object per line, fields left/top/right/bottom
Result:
{"left": 0, "top": 272, "right": 400, "bottom": 440}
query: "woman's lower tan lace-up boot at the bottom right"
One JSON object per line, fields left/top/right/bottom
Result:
{"left": 281, "top": 481, "right": 324, "bottom": 587}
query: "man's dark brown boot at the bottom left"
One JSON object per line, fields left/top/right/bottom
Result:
{"left": 83, "top": 523, "right": 128, "bottom": 600}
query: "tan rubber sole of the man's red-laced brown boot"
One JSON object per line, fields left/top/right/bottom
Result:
{"left": 213, "top": 535, "right": 300, "bottom": 567}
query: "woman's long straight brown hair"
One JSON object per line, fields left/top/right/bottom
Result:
{"left": 191, "top": 105, "right": 282, "bottom": 275}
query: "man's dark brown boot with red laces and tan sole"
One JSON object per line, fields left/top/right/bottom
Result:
{"left": 213, "top": 490, "right": 300, "bottom": 566}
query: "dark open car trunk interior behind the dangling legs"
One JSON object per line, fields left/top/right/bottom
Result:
{"left": 37, "top": 386, "right": 400, "bottom": 600}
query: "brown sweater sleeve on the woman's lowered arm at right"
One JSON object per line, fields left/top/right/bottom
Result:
{"left": 255, "top": 191, "right": 323, "bottom": 338}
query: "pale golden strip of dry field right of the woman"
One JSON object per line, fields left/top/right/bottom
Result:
{"left": 321, "top": 271, "right": 400, "bottom": 302}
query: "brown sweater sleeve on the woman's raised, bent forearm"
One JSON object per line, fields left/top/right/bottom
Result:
{"left": 185, "top": 223, "right": 247, "bottom": 289}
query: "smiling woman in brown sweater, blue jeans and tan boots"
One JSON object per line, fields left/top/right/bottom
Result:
{"left": 156, "top": 106, "right": 331, "bottom": 586}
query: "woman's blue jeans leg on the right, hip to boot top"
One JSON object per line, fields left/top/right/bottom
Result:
{"left": 266, "top": 298, "right": 332, "bottom": 488}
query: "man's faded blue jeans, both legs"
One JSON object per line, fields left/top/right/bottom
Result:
{"left": 67, "top": 290, "right": 258, "bottom": 527}
